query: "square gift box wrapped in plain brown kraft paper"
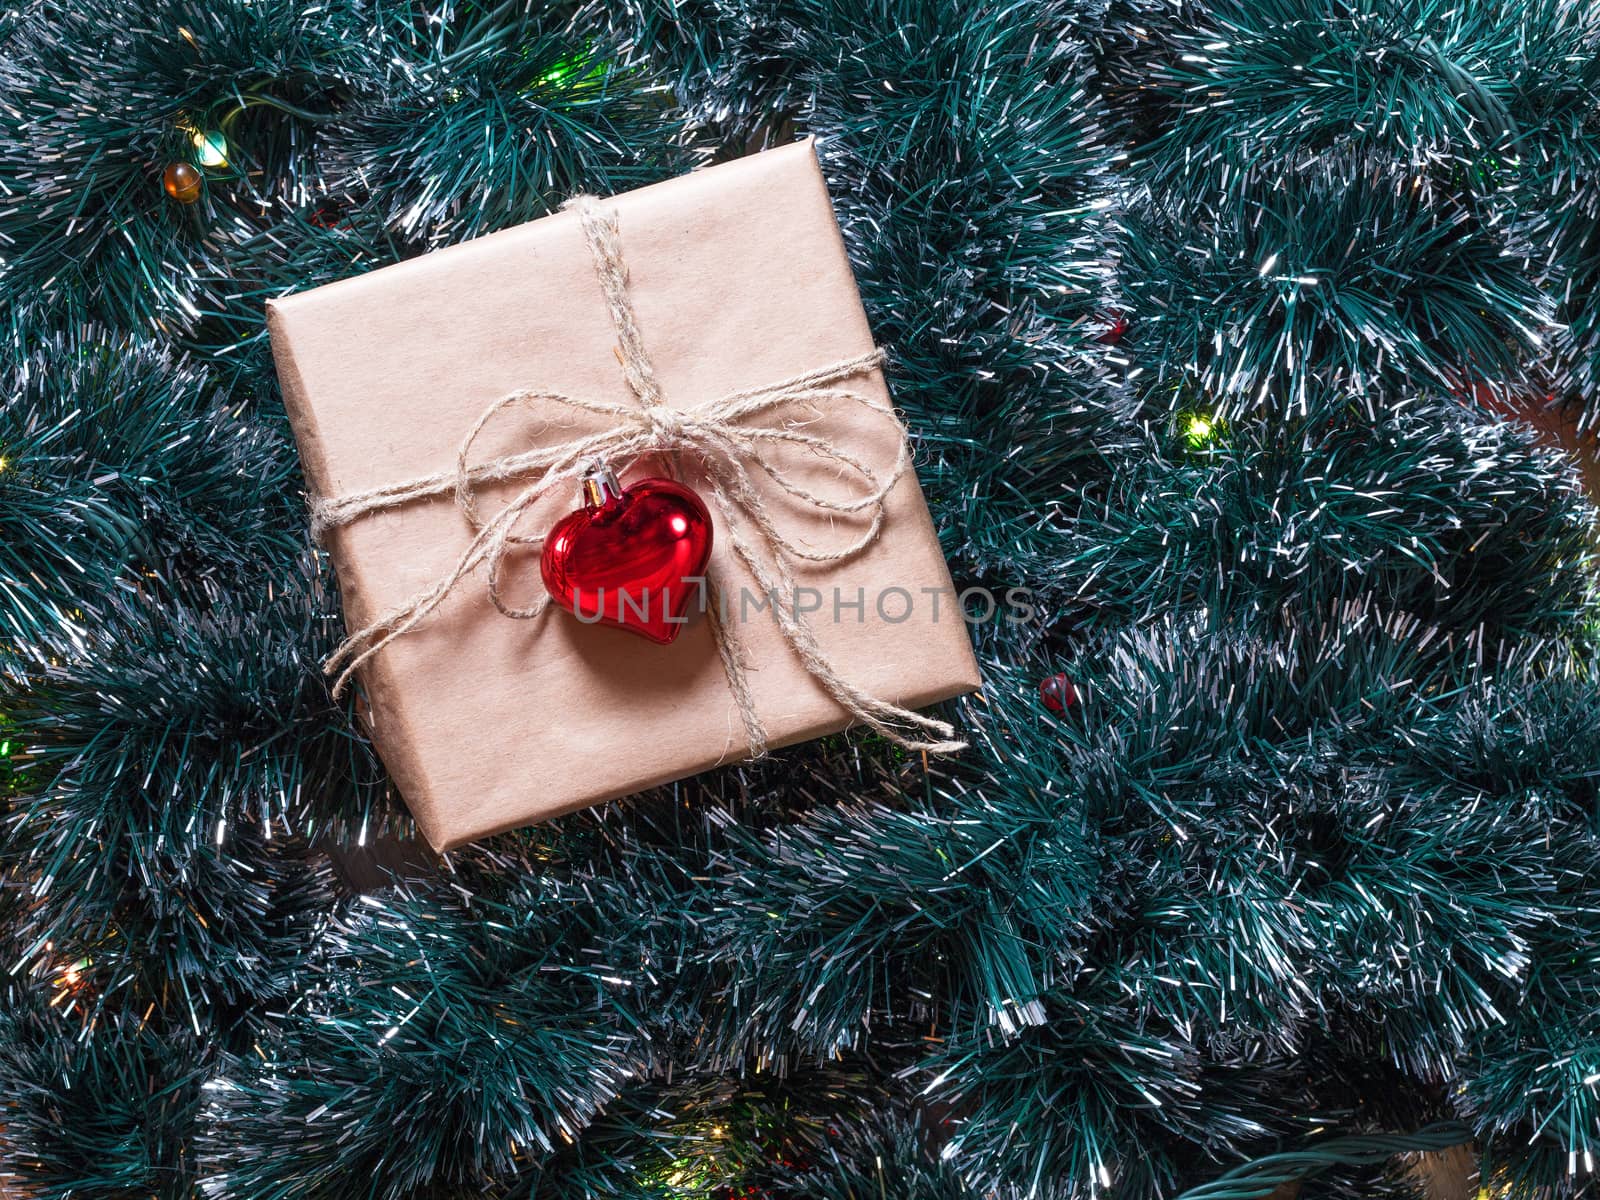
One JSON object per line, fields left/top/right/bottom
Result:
{"left": 267, "top": 142, "right": 979, "bottom": 850}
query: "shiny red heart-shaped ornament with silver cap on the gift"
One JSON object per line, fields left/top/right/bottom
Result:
{"left": 539, "top": 467, "right": 710, "bottom": 645}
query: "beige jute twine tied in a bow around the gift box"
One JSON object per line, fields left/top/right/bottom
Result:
{"left": 312, "top": 197, "right": 965, "bottom": 757}
